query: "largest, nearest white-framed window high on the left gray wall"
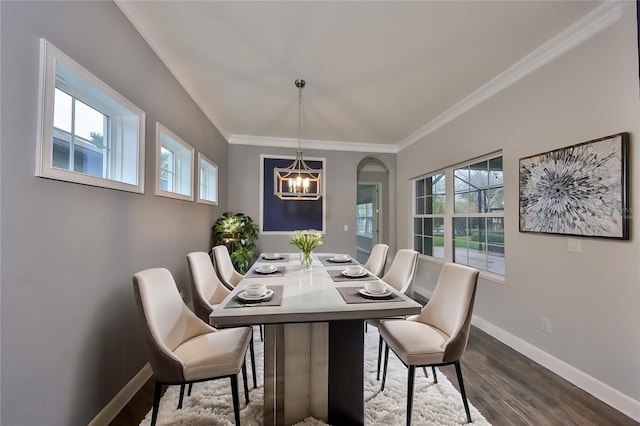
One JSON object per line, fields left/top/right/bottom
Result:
{"left": 36, "top": 39, "right": 145, "bottom": 193}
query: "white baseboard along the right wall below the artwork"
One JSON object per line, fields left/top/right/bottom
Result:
{"left": 417, "top": 289, "right": 640, "bottom": 421}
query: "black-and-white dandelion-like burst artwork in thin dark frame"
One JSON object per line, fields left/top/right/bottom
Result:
{"left": 520, "top": 133, "right": 628, "bottom": 239}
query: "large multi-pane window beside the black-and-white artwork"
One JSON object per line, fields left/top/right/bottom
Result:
{"left": 413, "top": 156, "right": 505, "bottom": 275}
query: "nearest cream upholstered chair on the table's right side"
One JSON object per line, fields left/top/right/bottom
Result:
{"left": 379, "top": 263, "right": 479, "bottom": 425}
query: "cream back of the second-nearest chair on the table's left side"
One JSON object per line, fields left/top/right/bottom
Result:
{"left": 187, "top": 251, "right": 231, "bottom": 323}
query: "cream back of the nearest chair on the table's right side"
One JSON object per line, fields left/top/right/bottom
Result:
{"left": 418, "top": 263, "right": 479, "bottom": 362}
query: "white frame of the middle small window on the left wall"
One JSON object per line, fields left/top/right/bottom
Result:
{"left": 156, "top": 122, "right": 195, "bottom": 201}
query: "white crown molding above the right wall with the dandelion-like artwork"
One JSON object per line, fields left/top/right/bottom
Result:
{"left": 397, "top": 0, "right": 622, "bottom": 152}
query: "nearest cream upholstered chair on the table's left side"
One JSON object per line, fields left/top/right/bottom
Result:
{"left": 133, "top": 268, "right": 251, "bottom": 425}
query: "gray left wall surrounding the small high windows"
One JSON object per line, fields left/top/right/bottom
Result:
{"left": 0, "top": 1, "right": 227, "bottom": 426}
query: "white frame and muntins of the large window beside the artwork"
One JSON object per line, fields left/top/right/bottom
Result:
{"left": 410, "top": 151, "right": 506, "bottom": 282}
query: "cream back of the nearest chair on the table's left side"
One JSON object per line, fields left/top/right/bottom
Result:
{"left": 133, "top": 268, "right": 215, "bottom": 383}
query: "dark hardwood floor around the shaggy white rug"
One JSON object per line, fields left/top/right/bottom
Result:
{"left": 111, "top": 327, "right": 640, "bottom": 426}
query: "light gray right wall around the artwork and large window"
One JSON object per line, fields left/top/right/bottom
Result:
{"left": 397, "top": 2, "right": 640, "bottom": 402}
